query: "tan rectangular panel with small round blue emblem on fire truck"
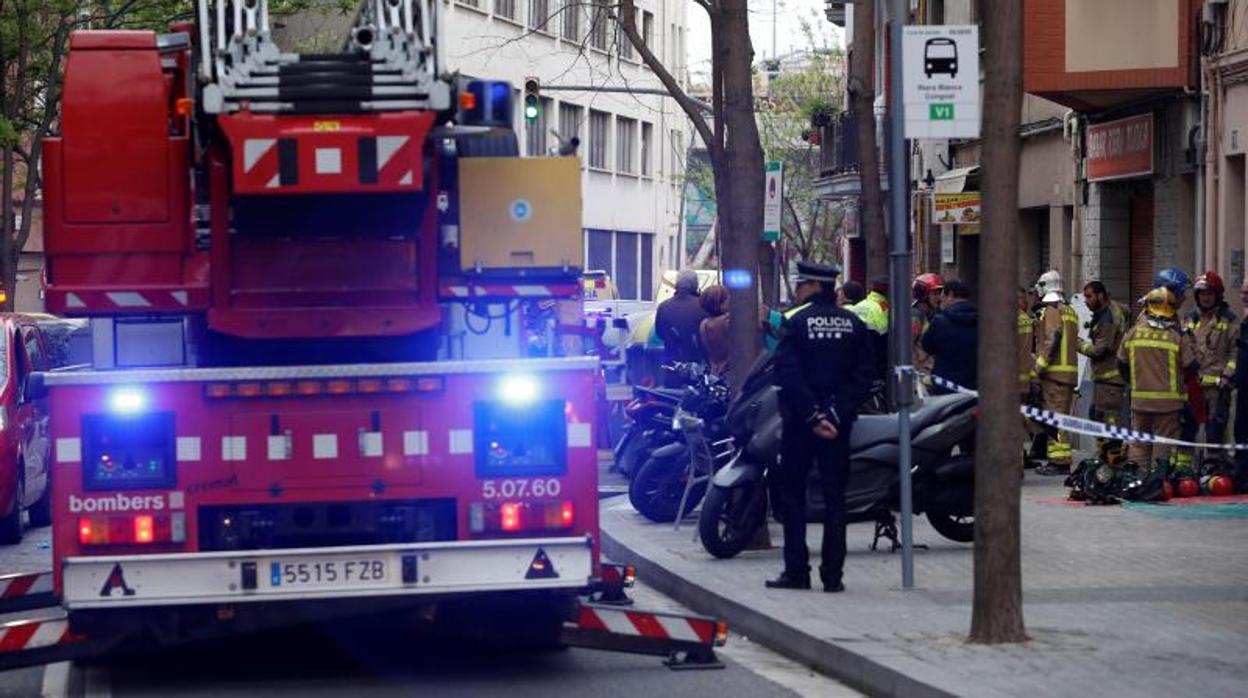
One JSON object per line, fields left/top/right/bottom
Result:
{"left": 459, "top": 157, "right": 584, "bottom": 270}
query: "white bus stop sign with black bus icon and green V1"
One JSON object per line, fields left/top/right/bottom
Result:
{"left": 901, "top": 25, "right": 981, "bottom": 139}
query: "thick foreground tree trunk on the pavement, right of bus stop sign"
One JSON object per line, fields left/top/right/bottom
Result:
{"left": 970, "top": 0, "right": 1027, "bottom": 644}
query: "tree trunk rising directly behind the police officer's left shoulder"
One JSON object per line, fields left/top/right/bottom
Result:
{"left": 715, "top": 0, "right": 765, "bottom": 386}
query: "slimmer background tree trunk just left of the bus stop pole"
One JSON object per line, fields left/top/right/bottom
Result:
{"left": 850, "top": 0, "right": 889, "bottom": 280}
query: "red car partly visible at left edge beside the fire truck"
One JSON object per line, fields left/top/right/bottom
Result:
{"left": 0, "top": 313, "right": 56, "bottom": 543}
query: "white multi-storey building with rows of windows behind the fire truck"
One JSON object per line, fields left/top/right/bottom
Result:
{"left": 441, "top": 0, "right": 690, "bottom": 300}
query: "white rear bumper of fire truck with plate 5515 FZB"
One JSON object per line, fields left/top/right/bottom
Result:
{"left": 62, "top": 537, "right": 593, "bottom": 611}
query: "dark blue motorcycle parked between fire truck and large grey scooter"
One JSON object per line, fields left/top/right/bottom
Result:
{"left": 628, "top": 365, "right": 731, "bottom": 523}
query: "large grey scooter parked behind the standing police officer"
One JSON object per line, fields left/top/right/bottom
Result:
{"left": 698, "top": 355, "right": 977, "bottom": 558}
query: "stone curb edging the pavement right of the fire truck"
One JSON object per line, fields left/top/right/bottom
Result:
{"left": 600, "top": 527, "right": 957, "bottom": 698}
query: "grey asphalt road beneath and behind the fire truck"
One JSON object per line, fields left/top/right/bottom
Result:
{"left": 0, "top": 516, "right": 857, "bottom": 698}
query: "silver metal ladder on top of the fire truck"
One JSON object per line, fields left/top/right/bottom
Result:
{"left": 196, "top": 0, "right": 451, "bottom": 114}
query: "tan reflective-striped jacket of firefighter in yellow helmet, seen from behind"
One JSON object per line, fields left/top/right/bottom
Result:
{"left": 1118, "top": 317, "right": 1196, "bottom": 415}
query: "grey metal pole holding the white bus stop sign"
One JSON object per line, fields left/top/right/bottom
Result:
{"left": 888, "top": 0, "right": 915, "bottom": 589}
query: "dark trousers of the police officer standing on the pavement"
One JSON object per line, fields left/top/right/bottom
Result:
{"left": 778, "top": 420, "right": 854, "bottom": 584}
